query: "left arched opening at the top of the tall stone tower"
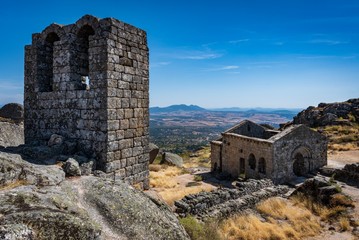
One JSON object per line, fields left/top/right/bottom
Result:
{"left": 38, "top": 32, "right": 60, "bottom": 92}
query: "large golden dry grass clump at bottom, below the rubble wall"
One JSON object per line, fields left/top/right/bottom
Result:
{"left": 220, "top": 198, "right": 321, "bottom": 240}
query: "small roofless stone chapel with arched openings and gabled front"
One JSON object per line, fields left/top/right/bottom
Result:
{"left": 211, "top": 120, "right": 327, "bottom": 183}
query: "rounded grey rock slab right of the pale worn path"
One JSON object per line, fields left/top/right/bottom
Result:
{"left": 83, "top": 178, "right": 189, "bottom": 240}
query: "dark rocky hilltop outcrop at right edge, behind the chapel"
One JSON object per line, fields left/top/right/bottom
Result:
{"left": 293, "top": 98, "right": 359, "bottom": 127}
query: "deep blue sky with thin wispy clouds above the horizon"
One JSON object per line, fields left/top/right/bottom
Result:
{"left": 0, "top": 0, "right": 359, "bottom": 108}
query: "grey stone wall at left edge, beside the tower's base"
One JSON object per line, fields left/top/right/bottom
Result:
{"left": 0, "top": 121, "right": 24, "bottom": 147}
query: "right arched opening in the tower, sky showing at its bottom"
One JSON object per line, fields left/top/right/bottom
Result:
{"left": 76, "top": 25, "right": 95, "bottom": 90}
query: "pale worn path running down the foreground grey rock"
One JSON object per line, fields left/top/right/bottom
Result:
{"left": 71, "top": 176, "right": 127, "bottom": 240}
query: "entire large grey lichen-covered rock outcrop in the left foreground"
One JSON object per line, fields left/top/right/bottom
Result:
{"left": 0, "top": 152, "right": 189, "bottom": 240}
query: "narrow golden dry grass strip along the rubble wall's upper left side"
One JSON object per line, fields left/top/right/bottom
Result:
{"left": 158, "top": 184, "right": 214, "bottom": 206}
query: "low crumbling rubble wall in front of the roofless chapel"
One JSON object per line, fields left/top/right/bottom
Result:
{"left": 175, "top": 179, "right": 288, "bottom": 220}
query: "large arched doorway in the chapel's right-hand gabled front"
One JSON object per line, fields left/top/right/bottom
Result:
{"left": 292, "top": 147, "right": 312, "bottom": 176}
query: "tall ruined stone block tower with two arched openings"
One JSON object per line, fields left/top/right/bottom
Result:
{"left": 24, "top": 15, "right": 149, "bottom": 188}
